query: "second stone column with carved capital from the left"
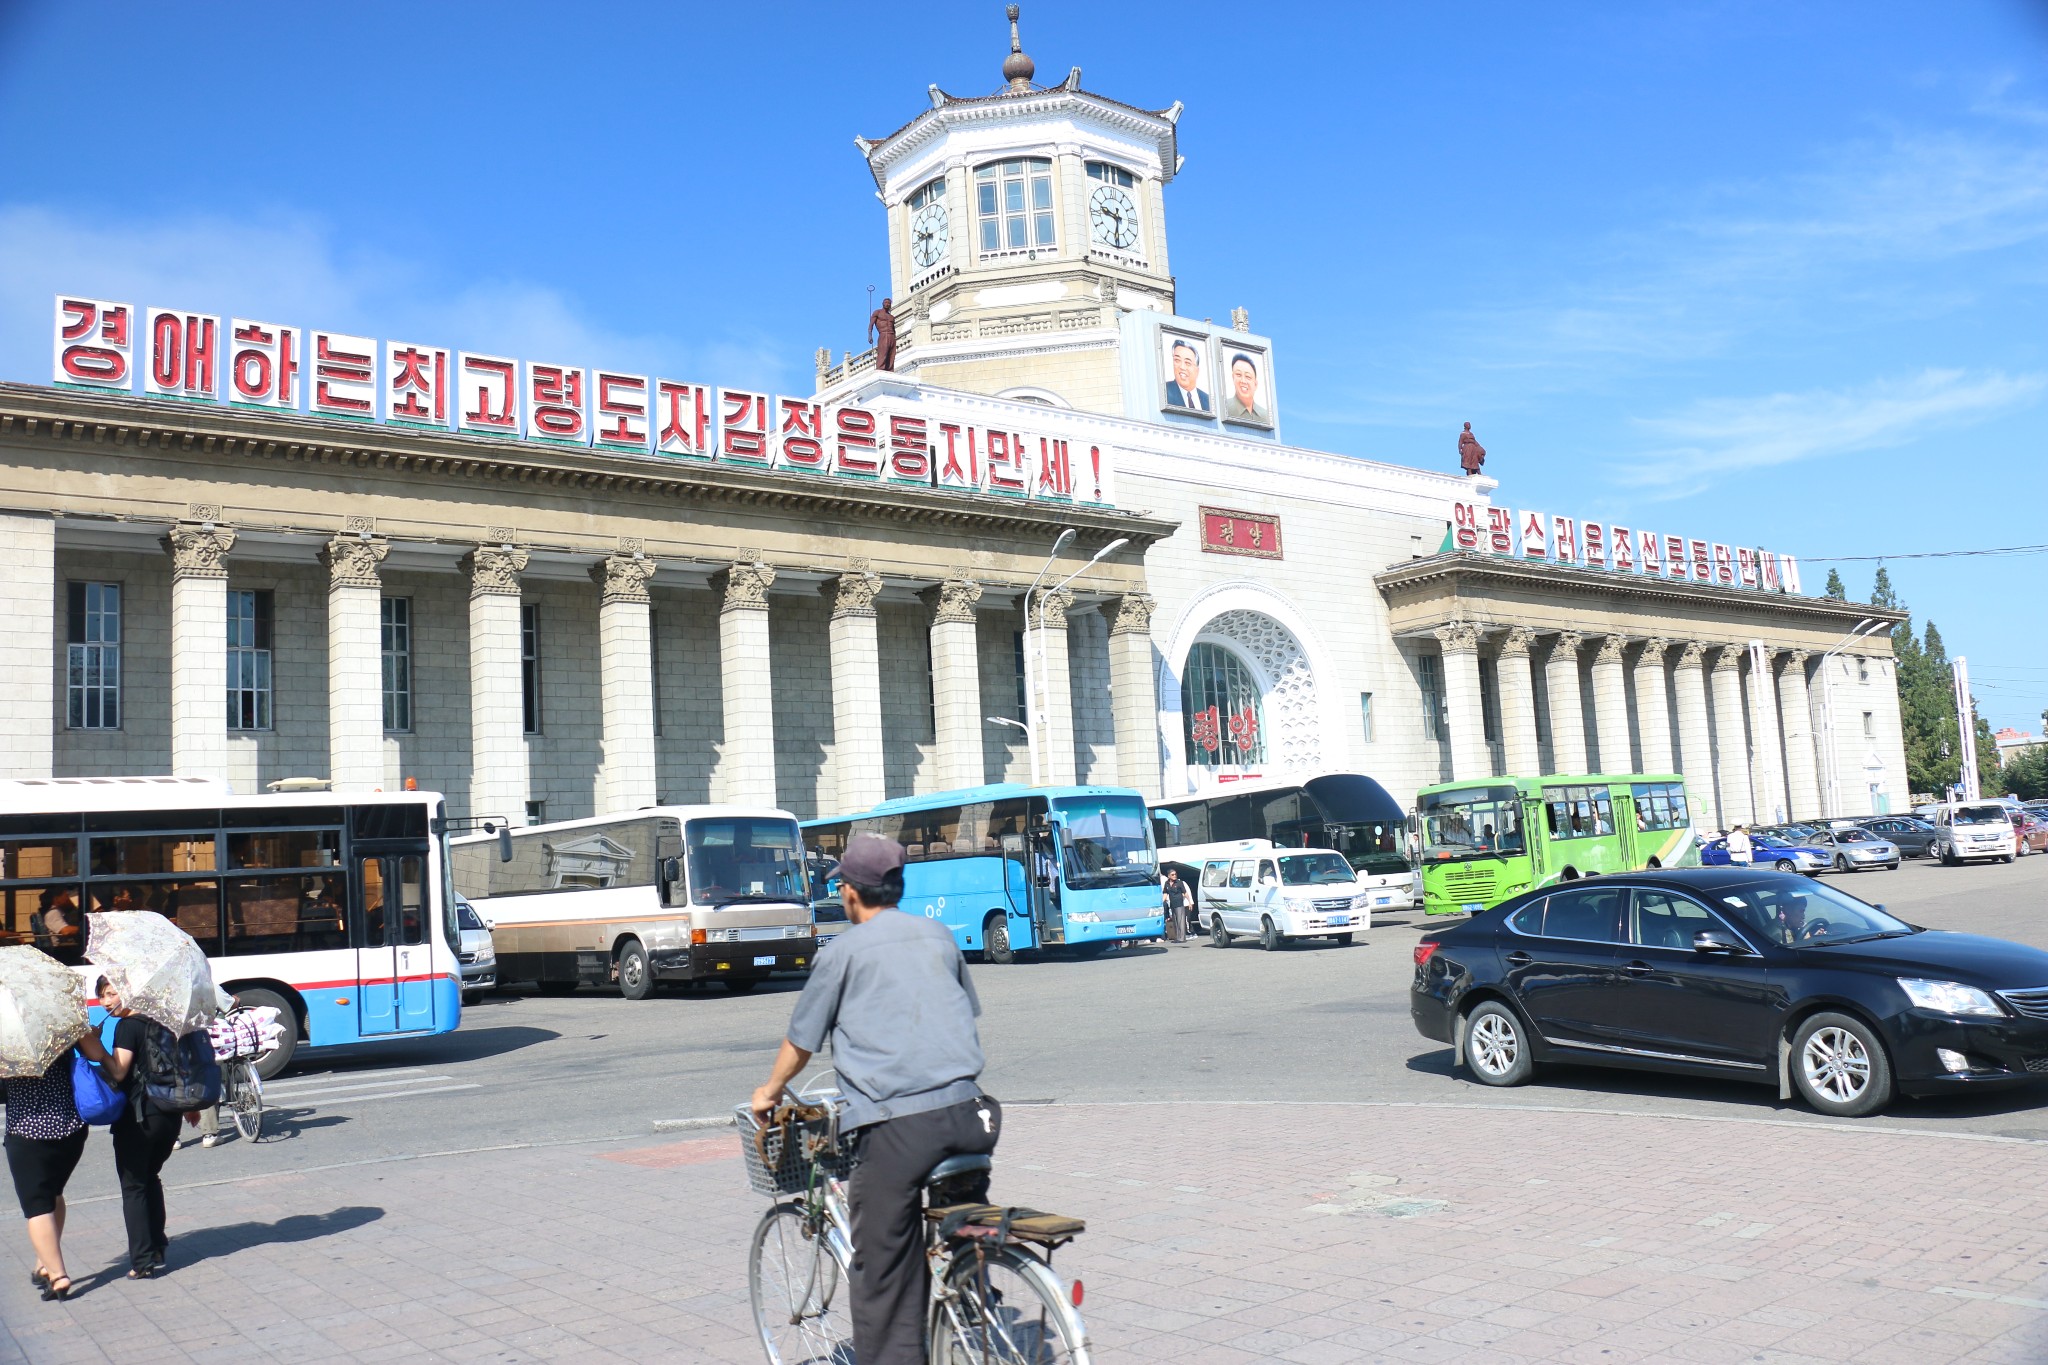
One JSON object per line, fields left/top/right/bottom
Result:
{"left": 319, "top": 534, "right": 391, "bottom": 792}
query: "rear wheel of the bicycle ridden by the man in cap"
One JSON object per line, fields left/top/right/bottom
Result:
{"left": 928, "top": 1246, "right": 1087, "bottom": 1365}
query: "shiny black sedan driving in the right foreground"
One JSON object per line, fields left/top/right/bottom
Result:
{"left": 1409, "top": 868, "right": 2048, "bottom": 1115}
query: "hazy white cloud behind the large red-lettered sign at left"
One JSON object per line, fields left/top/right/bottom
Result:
{"left": 0, "top": 205, "right": 794, "bottom": 393}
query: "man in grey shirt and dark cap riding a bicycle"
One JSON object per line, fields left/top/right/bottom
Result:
{"left": 754, "top": 835, "right": 1004, "bottom": 1365}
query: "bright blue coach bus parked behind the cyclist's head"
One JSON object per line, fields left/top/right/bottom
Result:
{"left": 803, "top": 782, "right": 1165, "bottom": 962}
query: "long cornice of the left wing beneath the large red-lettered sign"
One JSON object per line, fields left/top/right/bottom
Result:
{"left": 0, "top": 383, "right": 1178, "bottom": 544}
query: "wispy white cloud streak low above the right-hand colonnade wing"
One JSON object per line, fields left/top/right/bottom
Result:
{"left": 1614, "top": 370, "right": 2048, "bottom": 499}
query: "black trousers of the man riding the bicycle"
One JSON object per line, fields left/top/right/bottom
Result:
{"left": 846, "top": 1097, "right": 1004, "bottom": 1365}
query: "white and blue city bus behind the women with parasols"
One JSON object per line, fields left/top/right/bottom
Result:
{"left": 0, "top": 778, "right": 463, "bottom": 1078}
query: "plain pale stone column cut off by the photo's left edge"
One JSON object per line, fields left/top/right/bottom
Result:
{"left": 0, "top": 512, "right": 55, "bottom": 780}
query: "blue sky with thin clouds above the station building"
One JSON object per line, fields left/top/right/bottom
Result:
{"left": 0, "top": 0, "right": 2048, "bottom": 731}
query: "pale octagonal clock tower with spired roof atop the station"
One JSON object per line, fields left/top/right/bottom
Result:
{"left": 835, "top": 4, "right": 1182, "bottom": 415}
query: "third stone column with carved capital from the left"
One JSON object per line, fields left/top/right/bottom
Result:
{"left": 463, "top": 544, "right": 530, "bottom": 825}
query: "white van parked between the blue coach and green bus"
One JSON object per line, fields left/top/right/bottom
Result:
{"left": 1194, "top": 847, "right": 1372, "bottom": 952}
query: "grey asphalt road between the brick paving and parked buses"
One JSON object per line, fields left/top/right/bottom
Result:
{"left": 59, "top": 857, "right": 2048, "bottom": 1195}
